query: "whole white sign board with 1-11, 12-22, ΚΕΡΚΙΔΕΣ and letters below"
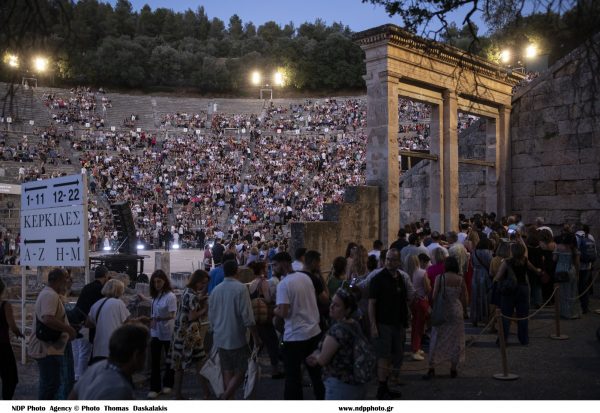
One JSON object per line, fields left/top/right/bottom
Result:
{"left": 21, "top": 175, "right": 88, "bottom": 267}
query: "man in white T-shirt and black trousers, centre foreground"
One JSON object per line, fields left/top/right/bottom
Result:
{"left": 272, "top": 252, "right": 325, "bottom": 400}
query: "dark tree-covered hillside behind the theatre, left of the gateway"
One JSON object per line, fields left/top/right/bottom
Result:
{"left": 0, "top": 0, "right": 364, "bottom": 92}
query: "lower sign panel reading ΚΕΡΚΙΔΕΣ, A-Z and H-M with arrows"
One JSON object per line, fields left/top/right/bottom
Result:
{"left": 21, "top": 205, "right": 87, "bottom": 266}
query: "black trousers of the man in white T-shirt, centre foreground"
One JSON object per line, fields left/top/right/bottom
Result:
{"left": 283, "top": 333, "right": 325, "bottom": 400}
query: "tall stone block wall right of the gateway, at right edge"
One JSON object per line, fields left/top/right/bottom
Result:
{"left": 511, "top": 36, "right": 600, "bottom": 239}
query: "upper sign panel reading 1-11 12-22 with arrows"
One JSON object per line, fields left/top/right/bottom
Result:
{"left": 21, "top": 175, "right": 84, "bottom": 211}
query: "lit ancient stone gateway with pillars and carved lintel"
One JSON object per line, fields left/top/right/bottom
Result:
{"left": 354, "top": 24, "right": 524, "bottom": 238}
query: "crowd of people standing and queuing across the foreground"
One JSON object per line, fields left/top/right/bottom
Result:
{"left": 0, "top": 214, "right": 597, "bottom": 400}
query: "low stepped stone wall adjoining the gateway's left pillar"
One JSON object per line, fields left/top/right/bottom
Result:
{"left": 289, "top": 186, "right": 380, "bottom": 271}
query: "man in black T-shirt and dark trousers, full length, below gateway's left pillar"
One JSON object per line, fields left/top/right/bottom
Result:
{"left": 369, "top": 249, "right": 408, "bottom": 400}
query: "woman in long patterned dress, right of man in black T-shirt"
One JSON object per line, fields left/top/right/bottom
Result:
{"left": 423, "top": 257, "right": 468, "bottom": 380}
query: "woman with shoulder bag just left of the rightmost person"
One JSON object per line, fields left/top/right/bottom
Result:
{"left": 554, "top": 233, "right": 581, "bottom": 320}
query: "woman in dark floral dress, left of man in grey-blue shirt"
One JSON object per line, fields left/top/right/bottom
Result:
{"left": 170, "top": 270, "right": 210, "bottom": 399}
